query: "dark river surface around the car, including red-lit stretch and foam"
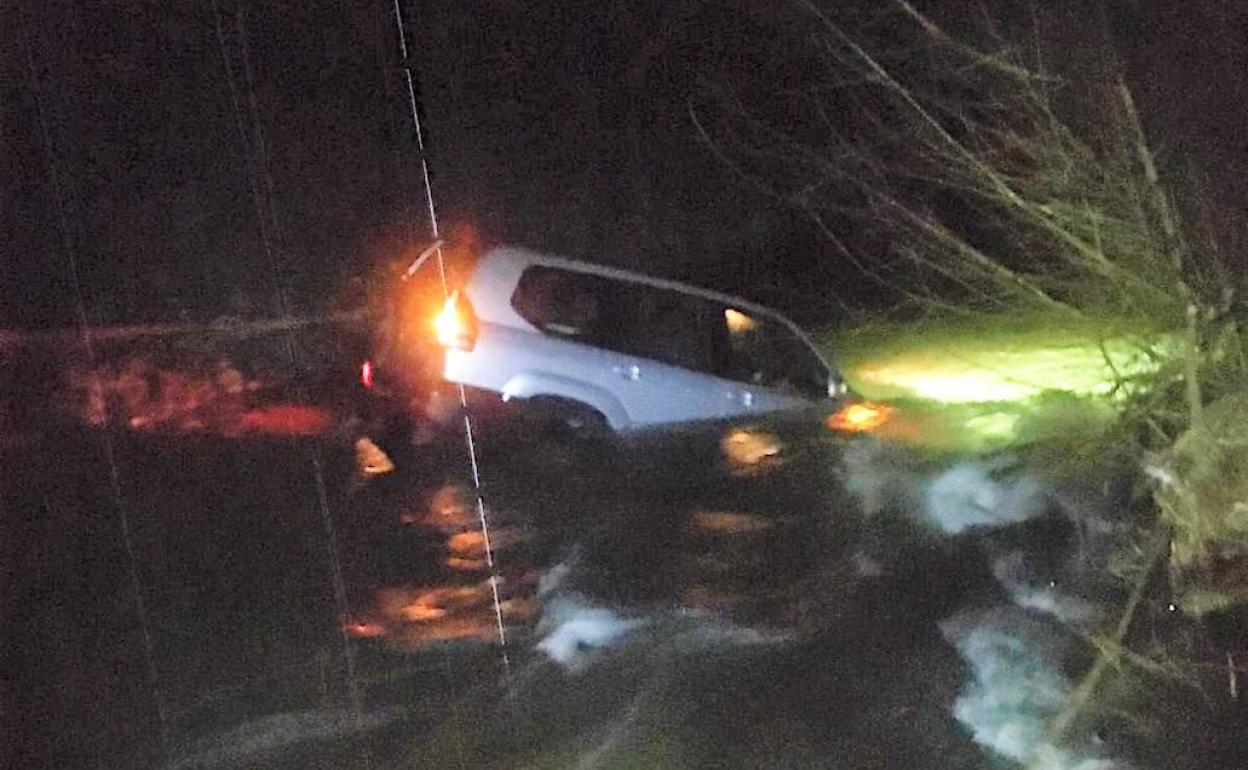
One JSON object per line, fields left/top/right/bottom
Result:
{"left": 9, "top": 341, "right": 1244, "bottom": 770}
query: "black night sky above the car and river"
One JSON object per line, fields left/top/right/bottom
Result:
{"left": 0, "top": 0, "right": 1248, "bottom": 326}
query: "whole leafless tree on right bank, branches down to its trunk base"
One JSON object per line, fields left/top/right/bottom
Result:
{"left": 691, "top": 0, "right": 1248, "bottom": 748}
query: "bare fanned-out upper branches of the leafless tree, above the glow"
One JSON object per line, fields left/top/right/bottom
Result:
{"left": 694, "top": 0, "right": 1234, "bottom": 422}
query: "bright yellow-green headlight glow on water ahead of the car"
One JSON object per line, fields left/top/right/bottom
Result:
{"left": 831, "top": 317, "right": 1178, "bottom": 452}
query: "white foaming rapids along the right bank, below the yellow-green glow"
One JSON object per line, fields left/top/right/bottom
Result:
{"left": 841, "top": 442, "right": 1123, "bottom": 770}
